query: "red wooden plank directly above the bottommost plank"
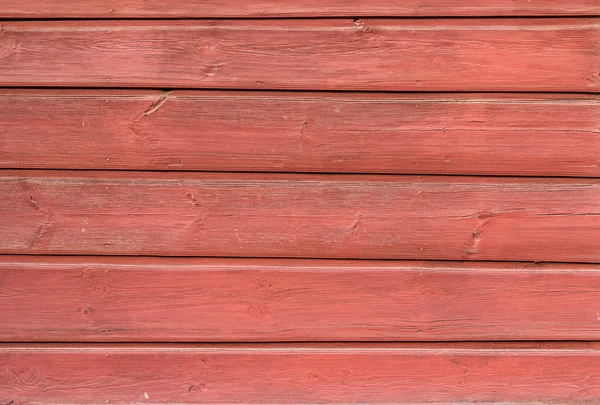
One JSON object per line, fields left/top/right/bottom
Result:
{"left": 0, "top": 256, "right": 600, "bottom": 342}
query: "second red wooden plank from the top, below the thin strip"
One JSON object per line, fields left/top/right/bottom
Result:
{"left": 0, "top": 18, "right": 600, "bottom": 92}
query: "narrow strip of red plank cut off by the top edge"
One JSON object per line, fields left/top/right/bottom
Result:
{"left": 0, "top": 0, "right": 600, "bottom": 18}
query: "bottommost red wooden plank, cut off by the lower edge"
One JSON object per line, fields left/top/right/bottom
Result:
{"left": 0, "top": 345, "right": 600, "bottom": 405}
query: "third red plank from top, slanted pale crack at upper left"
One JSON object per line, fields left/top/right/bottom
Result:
{"left": 0, "top": 90, "right": 600, "bottom": 177}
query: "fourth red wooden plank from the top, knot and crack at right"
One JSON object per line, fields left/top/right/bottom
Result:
{"left": 0, "top": 170, "right": 600, "bottom": 262}
